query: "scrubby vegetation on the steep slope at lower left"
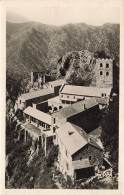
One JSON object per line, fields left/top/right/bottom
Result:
{"left": 6, "top": 118, "right": 58, "bottom": 189}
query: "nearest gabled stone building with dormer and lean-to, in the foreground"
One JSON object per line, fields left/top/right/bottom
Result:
{"left": 56, "top": 122, "right": 103, "bottom": 179}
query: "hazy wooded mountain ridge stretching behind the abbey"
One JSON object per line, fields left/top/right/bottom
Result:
{"left": 6, "top": 22, "right": 120, "bottom": 78}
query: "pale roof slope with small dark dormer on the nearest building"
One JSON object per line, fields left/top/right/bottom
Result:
{"left": 56, "top": 122, "right": 88, "bottom": 155}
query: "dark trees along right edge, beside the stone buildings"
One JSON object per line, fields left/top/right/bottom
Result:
{"left": 101, "top": 96, "right": 119, "bottom": 172}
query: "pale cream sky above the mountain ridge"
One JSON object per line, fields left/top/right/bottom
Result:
{"left": 6, "top": 1, "right": 120, "bottom": 26}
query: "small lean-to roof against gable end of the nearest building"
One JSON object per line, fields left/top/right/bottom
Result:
{"left": 72, "top": 159, "right": 91, "bottom": 170}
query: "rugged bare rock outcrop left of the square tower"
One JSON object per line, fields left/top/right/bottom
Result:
{"left": 57, "top": 50, "right": 96, "bottom": 85}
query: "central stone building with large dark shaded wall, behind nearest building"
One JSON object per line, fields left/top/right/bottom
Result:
{"left": 52, "top": 100, "right": 99, "bottom": 133}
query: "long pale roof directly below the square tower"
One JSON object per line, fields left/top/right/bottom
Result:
{"left": 61, "top": 85, "right": 111, "bottom": 97}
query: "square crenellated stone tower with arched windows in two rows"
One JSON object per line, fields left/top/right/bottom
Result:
{"left": 95, "top": 58, "right": 113, "bottom": 88}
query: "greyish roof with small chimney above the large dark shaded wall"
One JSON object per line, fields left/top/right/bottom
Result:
{"left": 59, "top": 100, "right": 97, "bottom": 118}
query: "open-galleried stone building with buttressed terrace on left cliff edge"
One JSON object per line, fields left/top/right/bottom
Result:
{"left": 19, "top": 106, "right": 53, "bottom": 156}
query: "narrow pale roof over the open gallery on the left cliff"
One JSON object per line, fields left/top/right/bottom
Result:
{"left": 23, "top": 106, "right": 51, "bottom": 125}
